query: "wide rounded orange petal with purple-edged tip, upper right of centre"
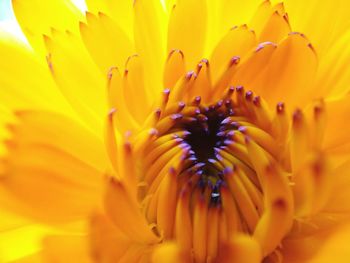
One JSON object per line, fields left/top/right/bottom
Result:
{"left": 249, "top": 33, "right": 318, "bottom": 108}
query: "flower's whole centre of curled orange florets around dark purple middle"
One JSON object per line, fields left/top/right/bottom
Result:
{"left": 140, "top": 82, "right": 291, "bottom": 262}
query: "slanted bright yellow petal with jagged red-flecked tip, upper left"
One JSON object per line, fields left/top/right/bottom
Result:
{"left": 44, "top": 31, "right": 107, "bottom": 132}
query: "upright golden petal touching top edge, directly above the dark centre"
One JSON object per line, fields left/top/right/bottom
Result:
{"left": 168, "top": 0, "right": 208, "bottom": 69}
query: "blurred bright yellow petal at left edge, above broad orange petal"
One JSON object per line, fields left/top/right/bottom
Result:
{"left": 0, "top": 34, "right": 73, "bottom": 114}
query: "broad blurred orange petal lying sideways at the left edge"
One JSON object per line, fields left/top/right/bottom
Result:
{"left": 0, "top": 112, "right": 107, "bottom": 223}
